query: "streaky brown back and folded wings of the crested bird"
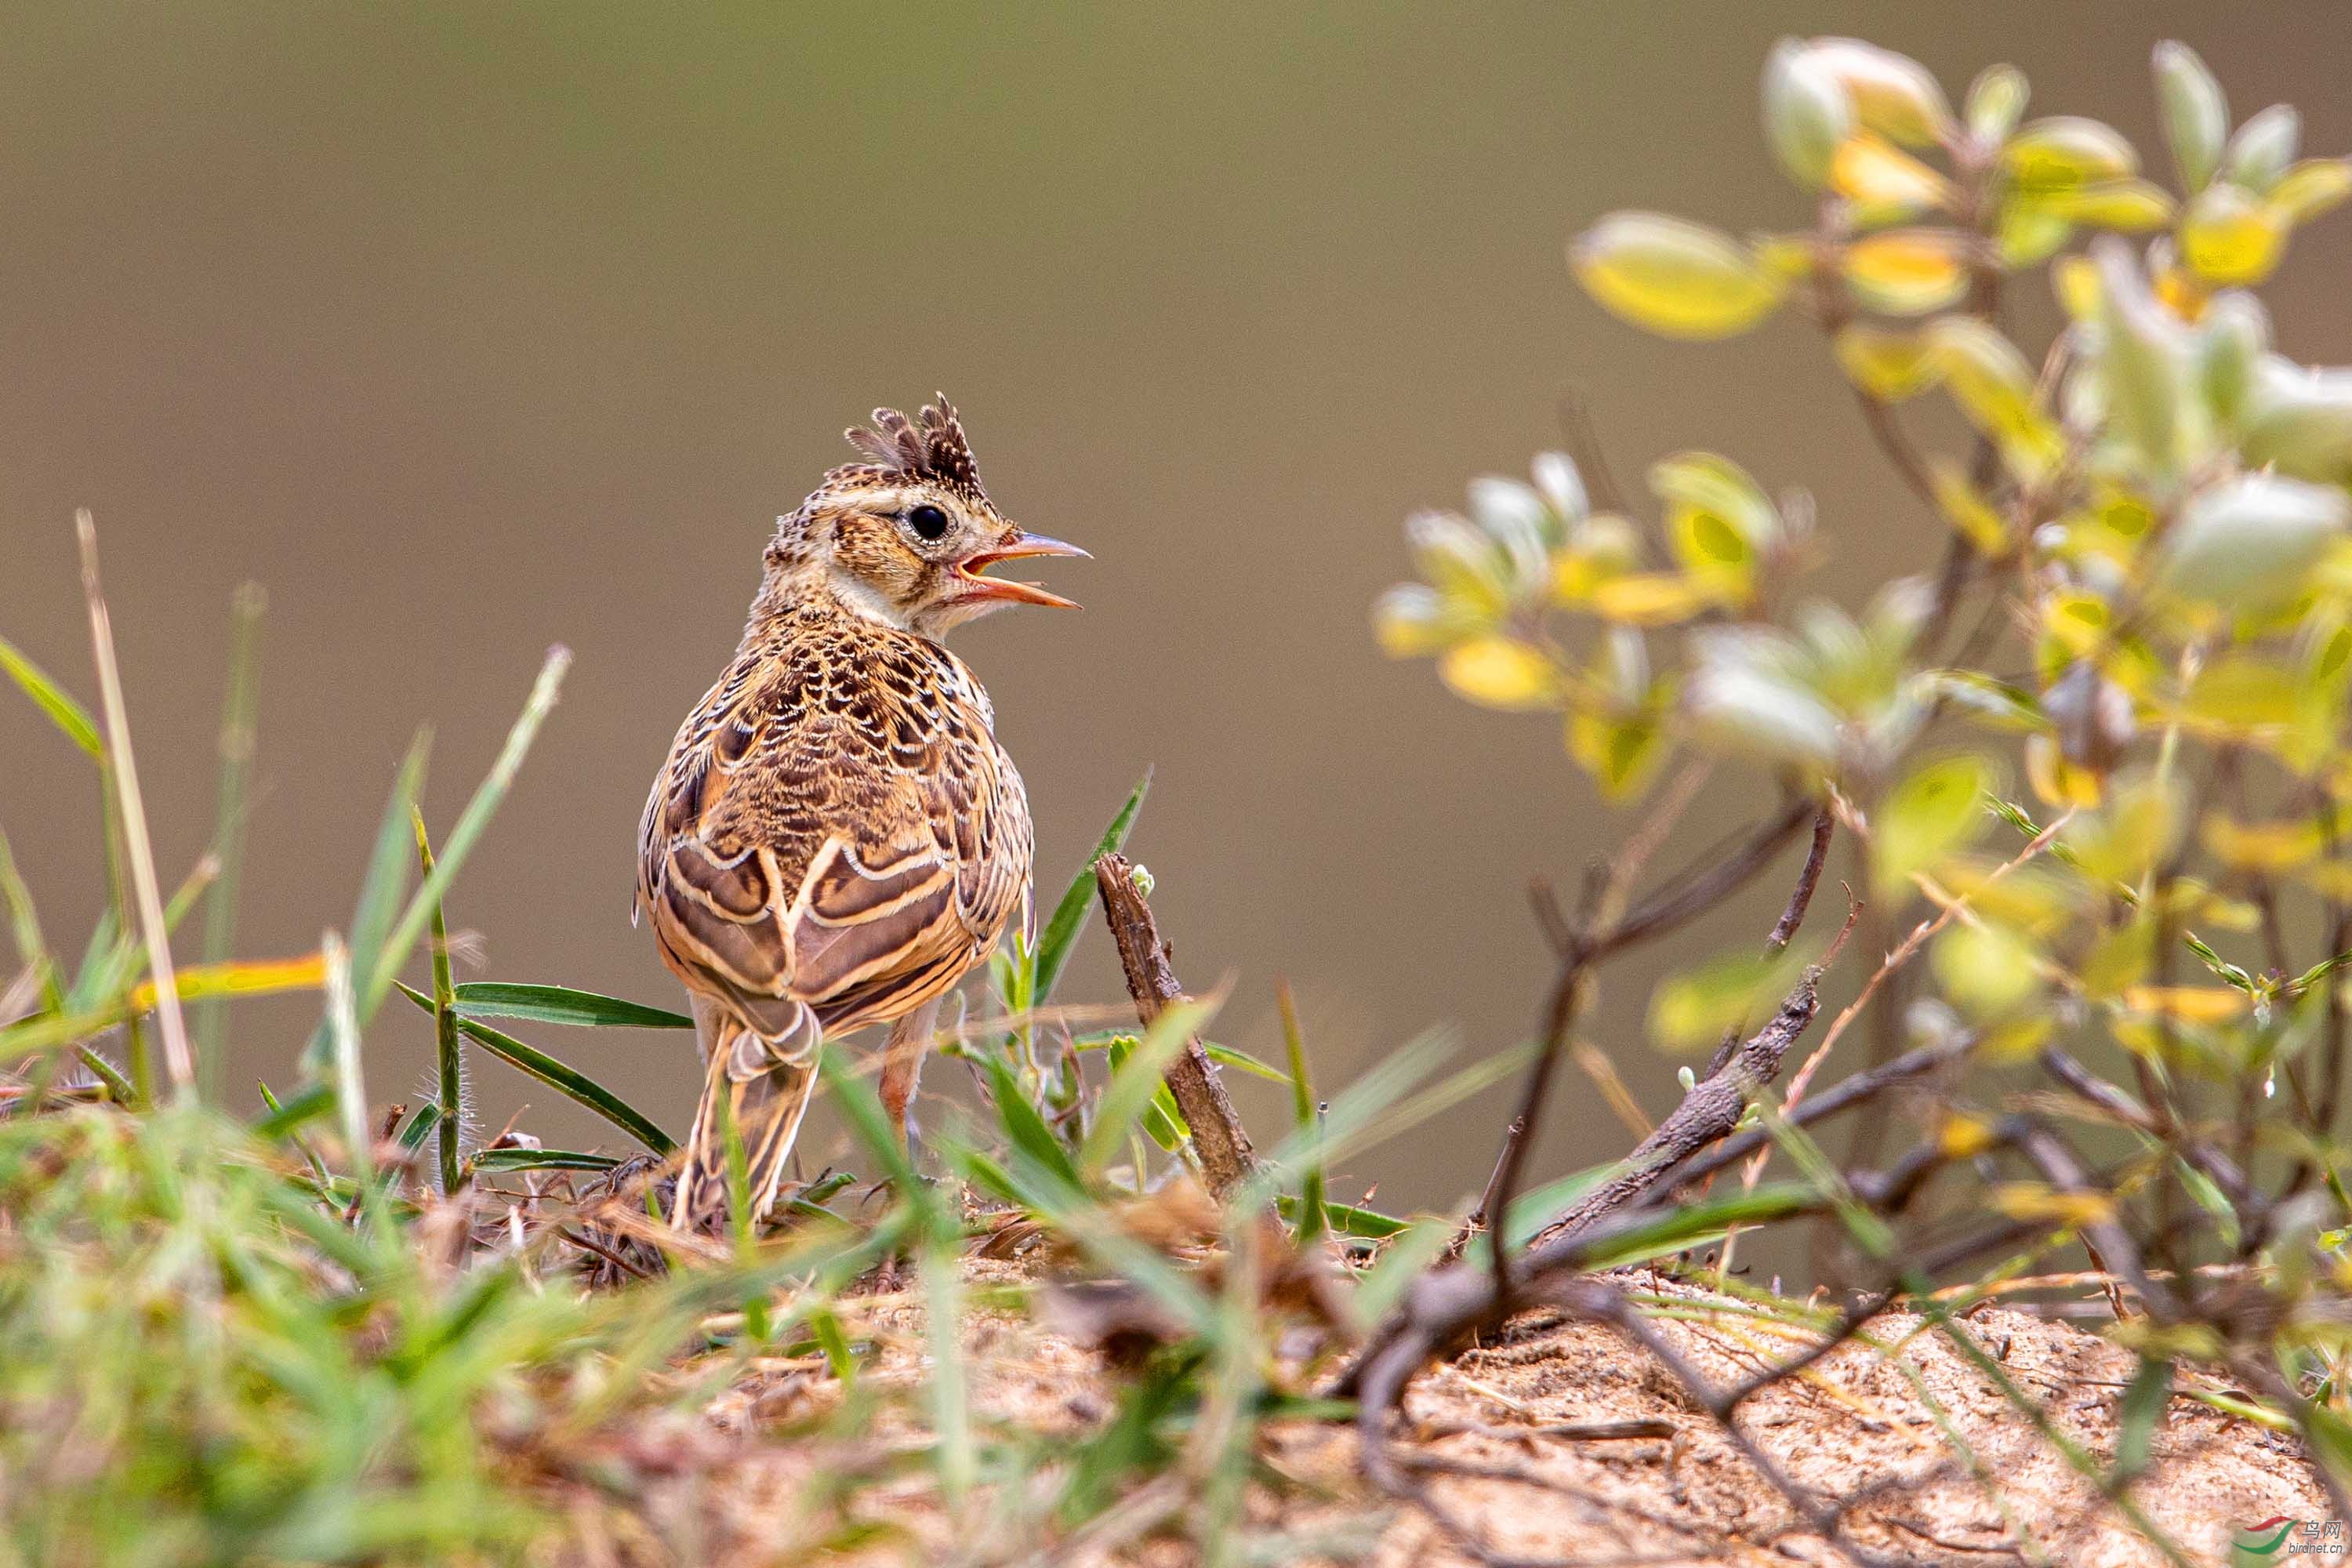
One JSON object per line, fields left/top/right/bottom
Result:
{"left": 640, "top": 640, "right": 1030, "bottom": 1034}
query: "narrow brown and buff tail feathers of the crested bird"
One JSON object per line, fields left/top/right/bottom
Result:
{"left": 670, "top": 1018, "right": 816, "bottom": 1229}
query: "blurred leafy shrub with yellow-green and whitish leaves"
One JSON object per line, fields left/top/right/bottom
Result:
{"left": 1376, "top": 38, "right": 2352, "bottom": 1504}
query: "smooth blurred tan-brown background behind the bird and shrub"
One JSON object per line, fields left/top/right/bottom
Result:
{"left": 0, "top": 0, "right": 2352, "bottom": 1203}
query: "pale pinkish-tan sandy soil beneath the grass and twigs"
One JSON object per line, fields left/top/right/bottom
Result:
{"left": 640, "top": 1262, "right": 2326, "bottom": 1568}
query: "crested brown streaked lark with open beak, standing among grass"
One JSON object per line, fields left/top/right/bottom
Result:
{"left": 637, "top": 397, "right": 1084, "bottom": 1225}
